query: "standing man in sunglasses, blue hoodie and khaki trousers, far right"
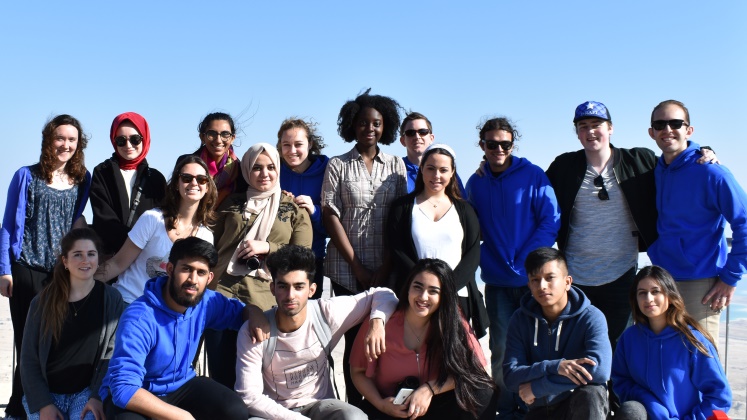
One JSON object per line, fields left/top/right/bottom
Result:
{"left": 648, "top": 100, "right": 747, "bottom": 343}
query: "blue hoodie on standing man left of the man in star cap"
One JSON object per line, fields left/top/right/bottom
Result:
{"left": 467, "top": 156, "right": 560, "bottom": 287}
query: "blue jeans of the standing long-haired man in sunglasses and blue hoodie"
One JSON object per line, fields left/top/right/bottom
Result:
{"left": 485, "top": 284, "right": 529, "bottom": 419}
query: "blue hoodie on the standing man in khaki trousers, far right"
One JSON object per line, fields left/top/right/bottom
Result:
{"left": 648, "top": 142, "right": 747, "bottom": 286}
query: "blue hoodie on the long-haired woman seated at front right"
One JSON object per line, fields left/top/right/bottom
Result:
{"left": 612, "top": 324, "right": 732, "bottom": 419}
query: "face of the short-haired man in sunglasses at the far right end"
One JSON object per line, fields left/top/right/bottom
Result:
{"left": 648, "top": 104, "right": 693, "bottom": 162}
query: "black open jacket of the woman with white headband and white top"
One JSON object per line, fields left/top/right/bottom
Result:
{"left": 386, "top": 193, "right": 490, "bottom": 338}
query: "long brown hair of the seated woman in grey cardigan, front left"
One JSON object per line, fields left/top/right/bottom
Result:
{"left": 37, "top": 228, "right": 102, "bottom": 342}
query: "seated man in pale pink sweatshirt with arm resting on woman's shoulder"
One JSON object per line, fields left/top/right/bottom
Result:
{"left": 236, "top": 245, "right": 397, "bottom": 420}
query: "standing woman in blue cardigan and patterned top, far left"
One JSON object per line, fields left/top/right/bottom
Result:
{"left": 0, "top": 114, "right": 91, "bottom": 417}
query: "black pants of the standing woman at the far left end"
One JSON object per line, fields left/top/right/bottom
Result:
{"left": 5, "top": 262, "right": 52, "bottom": 418}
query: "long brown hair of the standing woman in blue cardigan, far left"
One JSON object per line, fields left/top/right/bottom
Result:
{"left": 39, "top": 114, "right": 88, "bottom": 184}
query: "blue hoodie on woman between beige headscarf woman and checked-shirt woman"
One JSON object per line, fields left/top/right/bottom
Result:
{"left": 280, "top": 155, "right": 329, "bottom": 258}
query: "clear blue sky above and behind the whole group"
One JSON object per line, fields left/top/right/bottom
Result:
{"left": 0, "top": 0, "right": 747, "bottom": 308}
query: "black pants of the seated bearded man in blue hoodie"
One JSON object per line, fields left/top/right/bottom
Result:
{"left": 104, "top": 376, "right": 249, "bottom": 420}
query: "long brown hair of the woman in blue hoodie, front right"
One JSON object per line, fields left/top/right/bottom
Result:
{"left": 629, "top": 265, "right": 716, "bottom": 357}
